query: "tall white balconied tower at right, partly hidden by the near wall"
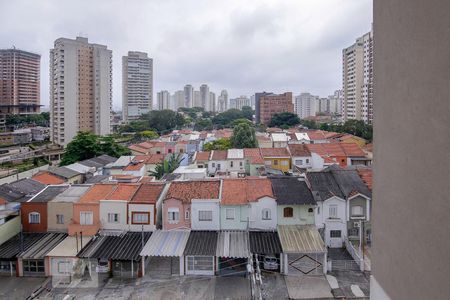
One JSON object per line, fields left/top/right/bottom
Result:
{"left": 342, "top": 27, "right": 373, "bottom": 123}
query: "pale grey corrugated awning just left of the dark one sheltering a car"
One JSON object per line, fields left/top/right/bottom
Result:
{"left": 216, "top": 231, "right": 250, "bottom": 258}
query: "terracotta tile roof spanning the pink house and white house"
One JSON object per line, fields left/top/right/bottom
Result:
{"left": 166, "top": 180, "right": 220, "bottom": 203}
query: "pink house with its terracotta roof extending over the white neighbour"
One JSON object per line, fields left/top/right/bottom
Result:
{"left": 162, "top": 180, "right": 220, "bottom": 230}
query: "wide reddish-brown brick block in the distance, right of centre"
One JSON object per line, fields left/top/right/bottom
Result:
{"left": 259, "top": 92, "right": 294, "bottom": 124}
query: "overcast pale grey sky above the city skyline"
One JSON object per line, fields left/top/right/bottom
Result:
{"left": 0, "top": 0, "right": 372, "bottom": 109}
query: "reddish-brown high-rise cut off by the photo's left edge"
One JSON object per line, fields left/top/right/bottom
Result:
{"left": 0, "top": 48, "right": 41, "bottom": 114}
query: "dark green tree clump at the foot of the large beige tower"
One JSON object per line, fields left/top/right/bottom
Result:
{"left": 60, "top": 132, "right": 130, "bottom": 166}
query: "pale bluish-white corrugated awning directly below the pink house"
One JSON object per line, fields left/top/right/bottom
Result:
{"left": 140, "top": 230, "right": 190, "bottom": 257}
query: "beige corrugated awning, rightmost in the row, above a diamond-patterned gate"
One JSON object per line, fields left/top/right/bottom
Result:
{"left": 278, "top": 225, "right": 327, "bottom": 253}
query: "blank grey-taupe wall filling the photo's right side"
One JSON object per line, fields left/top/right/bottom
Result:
{"left": 371, "top": 0, "right": 450, "bottom": 299}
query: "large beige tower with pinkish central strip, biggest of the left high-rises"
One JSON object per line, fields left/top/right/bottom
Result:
{"left": 50, "top": 37, "right": 112, "bottom": 145}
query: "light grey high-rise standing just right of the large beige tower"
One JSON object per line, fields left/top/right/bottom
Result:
{"left": 122, "top": 51, "right": 153, "bottom": 122}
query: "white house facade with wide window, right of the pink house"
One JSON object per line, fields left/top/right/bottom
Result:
{"left": 191, "top": 199, "right": 220, "bottom": 230}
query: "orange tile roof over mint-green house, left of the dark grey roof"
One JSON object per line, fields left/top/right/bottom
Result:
{"left": 221, "top": 177, "right": 274, "bottom": 205}
